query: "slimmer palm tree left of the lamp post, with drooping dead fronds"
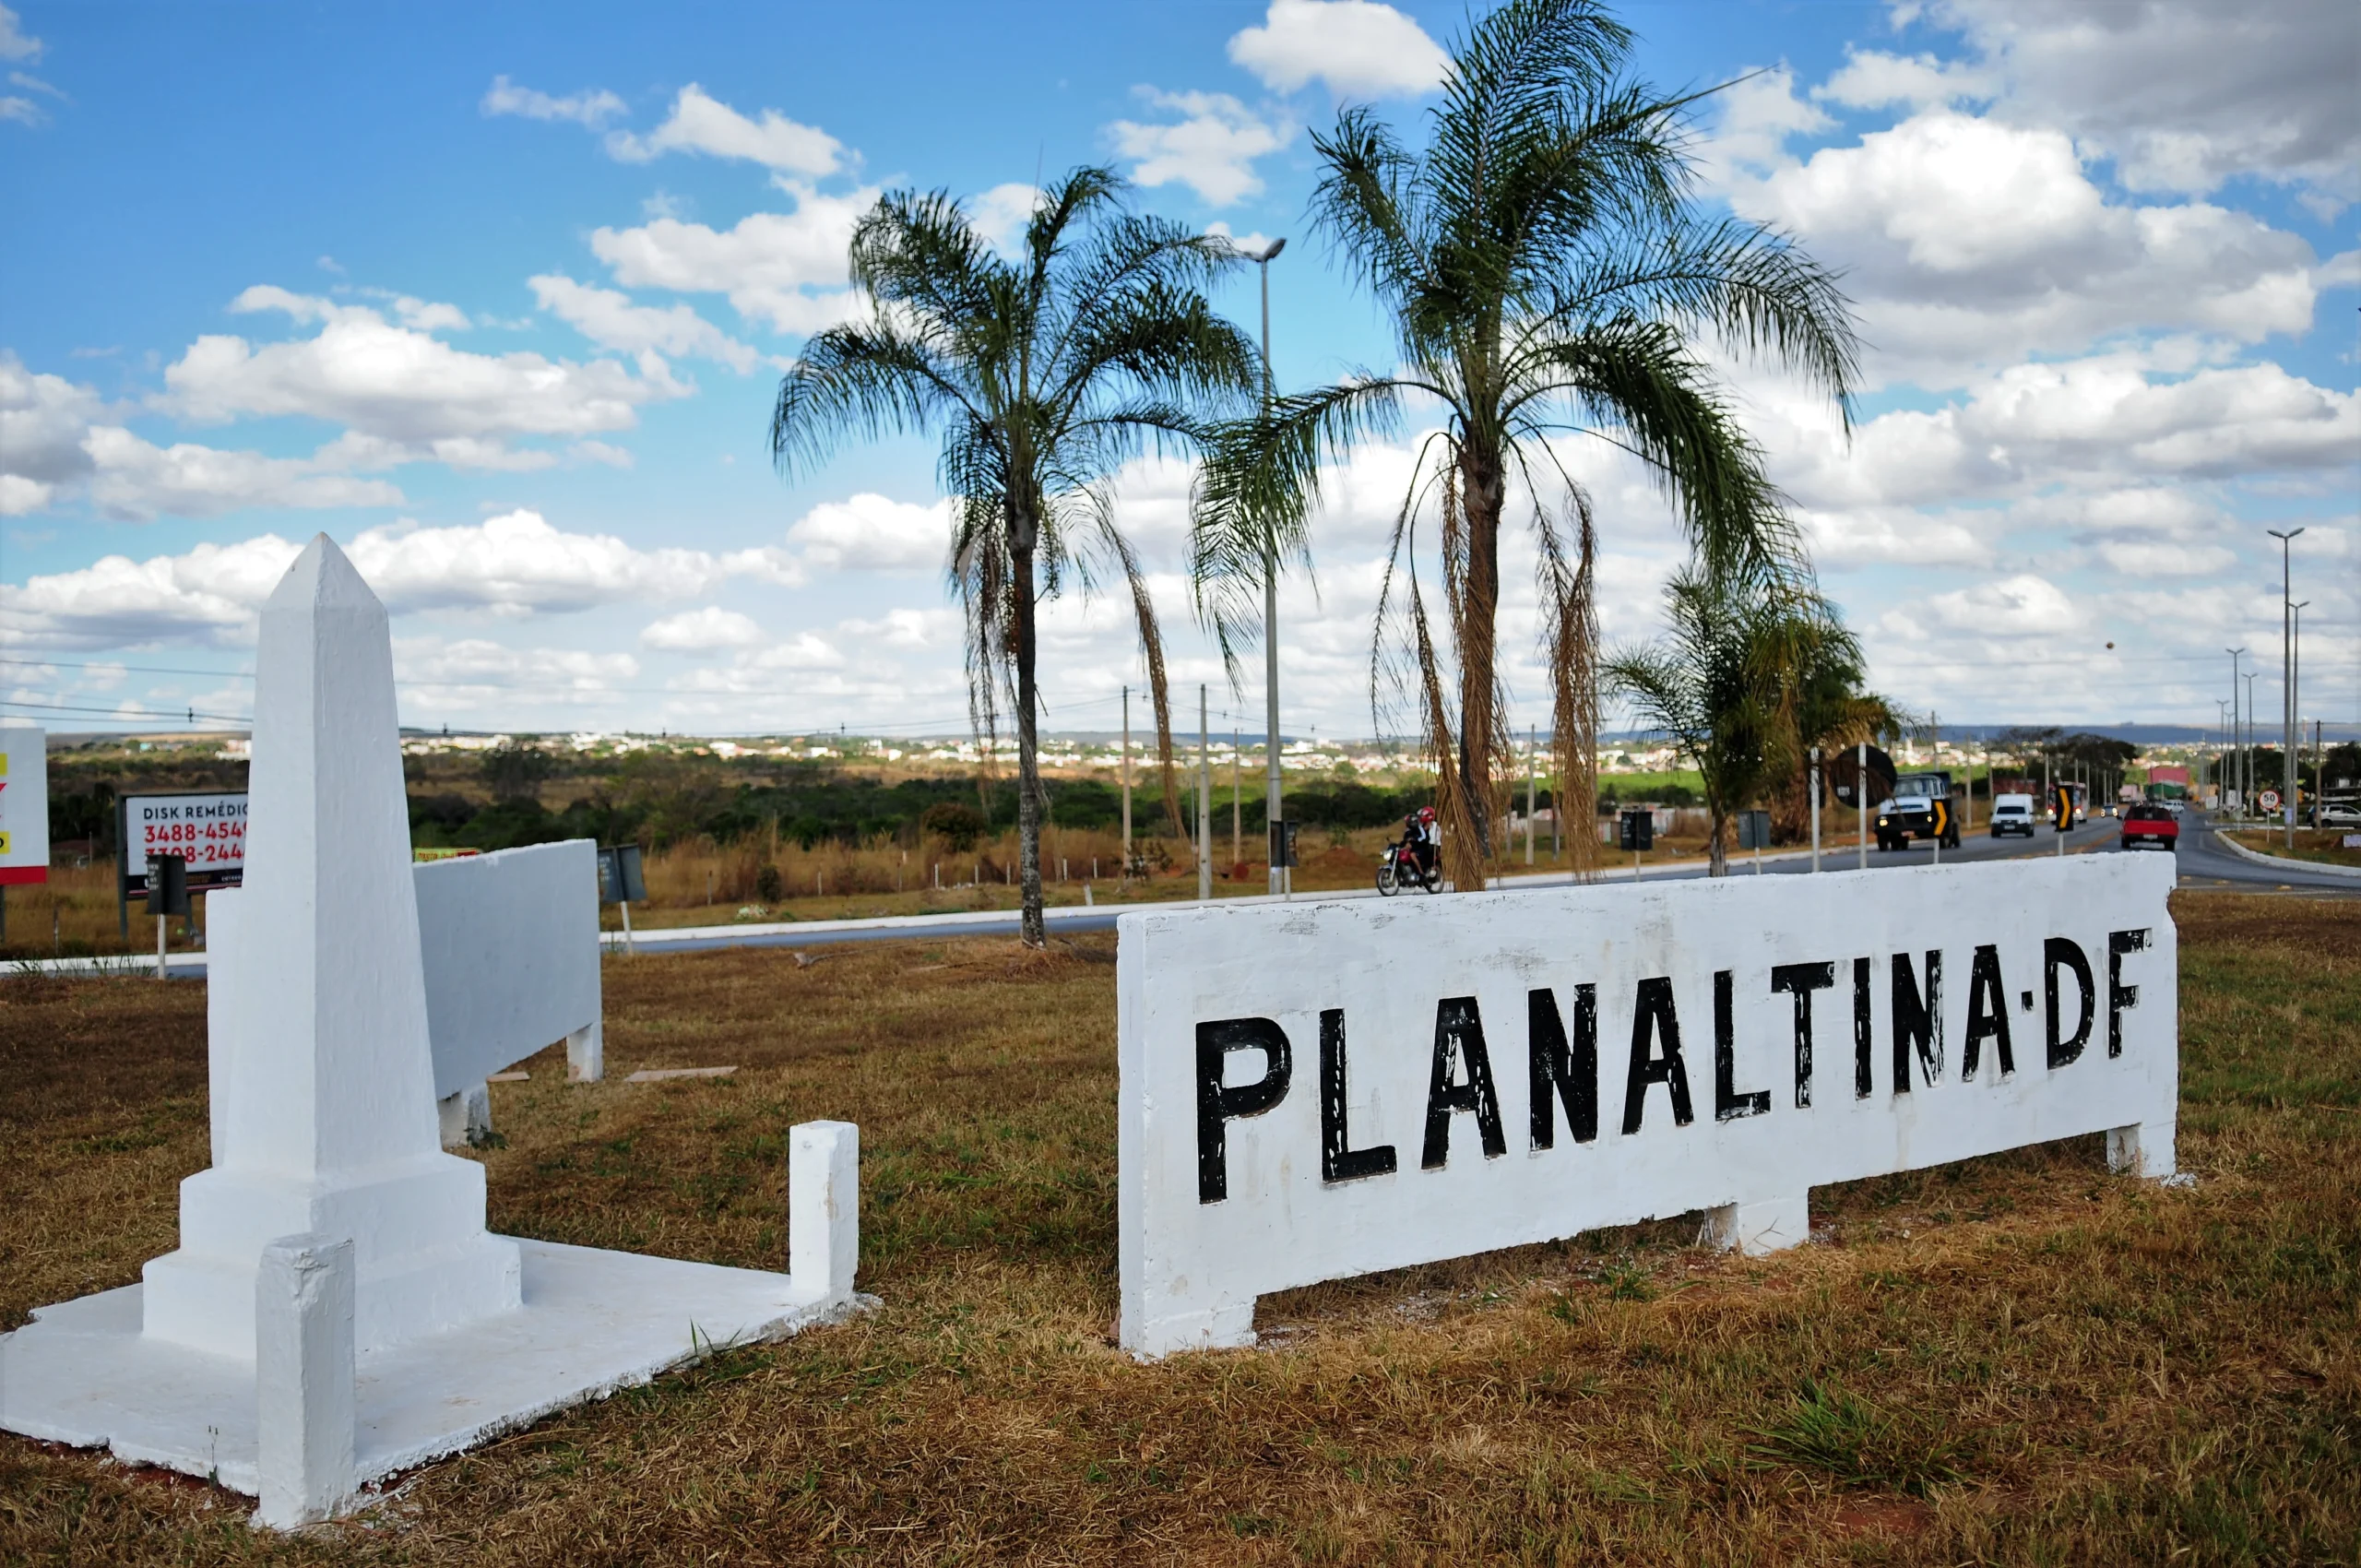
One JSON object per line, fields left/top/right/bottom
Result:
{"left": 770, "top": 168, "right": 1258, "bottom": 947}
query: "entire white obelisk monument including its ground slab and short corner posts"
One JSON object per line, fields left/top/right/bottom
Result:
{"left": 0, "top": 536, "right": 873, "bottom": 1526}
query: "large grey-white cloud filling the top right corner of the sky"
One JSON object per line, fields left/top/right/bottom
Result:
{"left": 1929, "top": 0, "right": 2361, "bottom": 206}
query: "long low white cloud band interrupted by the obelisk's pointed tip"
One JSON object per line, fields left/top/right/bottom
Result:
{"left": 0, "top": 510, "right": 802, "bottom": 647}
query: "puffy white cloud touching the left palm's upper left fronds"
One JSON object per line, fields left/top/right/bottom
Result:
{"left": 590, "top": 186, "right": 878, "bottom": 333}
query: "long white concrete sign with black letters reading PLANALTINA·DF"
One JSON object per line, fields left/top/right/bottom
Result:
{"left": 1117, "top": 855, "right": 2179, "bottom": 1356}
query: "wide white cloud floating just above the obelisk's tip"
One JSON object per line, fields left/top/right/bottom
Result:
{"left": 159, "top": 288, "right": 684, "bottom": 468}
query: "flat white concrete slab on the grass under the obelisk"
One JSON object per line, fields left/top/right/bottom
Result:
{"left": 0, "top": 1242, "right": 876, "bottom": 1495}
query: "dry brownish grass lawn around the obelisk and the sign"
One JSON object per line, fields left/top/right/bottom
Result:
{"left": 0, "top": 895, "right": 2361, "bottom": 1563}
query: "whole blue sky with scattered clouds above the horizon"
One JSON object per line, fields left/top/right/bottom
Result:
{"left": 0, "top": 0, "right": 2361, "bottom": 734}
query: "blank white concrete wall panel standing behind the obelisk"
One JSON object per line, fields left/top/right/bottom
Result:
{"left": 413, "top": 838, "right": 599, "bottom": 1100}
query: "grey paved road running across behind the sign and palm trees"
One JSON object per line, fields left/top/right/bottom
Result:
{"left": 22, "top": 813, "right": 2361, "bottom": 980}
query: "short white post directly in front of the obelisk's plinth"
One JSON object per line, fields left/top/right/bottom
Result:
{"left": 255, "top": 1232, "right": 359, "bottom": 1530}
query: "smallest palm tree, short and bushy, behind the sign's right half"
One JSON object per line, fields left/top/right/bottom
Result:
{"left": 1603, "top": 566, "right": 1860, "bottom": 876}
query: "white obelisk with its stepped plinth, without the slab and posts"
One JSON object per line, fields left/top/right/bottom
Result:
{"left": 144, "top": 534, "right": 519, "bottom": 1358}
